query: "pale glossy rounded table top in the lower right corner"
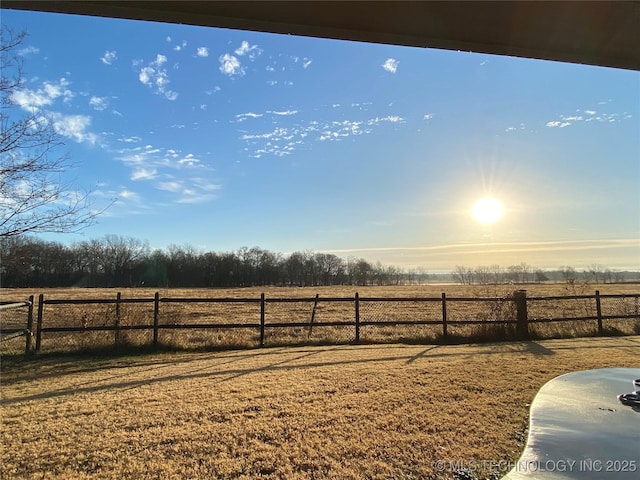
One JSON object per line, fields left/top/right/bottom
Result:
{"left": 504, "top": 370, "right": 640, "bottom": 480}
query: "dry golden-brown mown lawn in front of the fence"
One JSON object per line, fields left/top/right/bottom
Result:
{"left": 0, "top": 336, "right": 640, "bottom": 479}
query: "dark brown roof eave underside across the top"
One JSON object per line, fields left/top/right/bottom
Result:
{"left": 0, "top": 0, "right": 640, "bottom": 70}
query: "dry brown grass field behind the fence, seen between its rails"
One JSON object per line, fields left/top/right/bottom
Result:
{"left": 0, "top": 283, "right": 640, "bottom": 355}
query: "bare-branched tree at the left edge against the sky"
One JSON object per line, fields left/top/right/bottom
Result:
{"left": 0, "top": 25, "right": 101, "bottom": 237}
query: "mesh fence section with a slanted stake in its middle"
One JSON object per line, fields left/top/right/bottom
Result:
{"left": 265, "top": 298, "right": 355, "bottom": 345}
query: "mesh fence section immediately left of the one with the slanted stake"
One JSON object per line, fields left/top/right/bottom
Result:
{"left": 158, "top": 299, "right": 260, "bottom": 349}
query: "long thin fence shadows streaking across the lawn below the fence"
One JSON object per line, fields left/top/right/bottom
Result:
{"left": 0, "top": 338, "right": 640, "bottom": 405}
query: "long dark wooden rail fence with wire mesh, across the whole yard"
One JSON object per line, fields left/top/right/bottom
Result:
{"left": 0, "top": 290, "right": 640, "bottom": 355}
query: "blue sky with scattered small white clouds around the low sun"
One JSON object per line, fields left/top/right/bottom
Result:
{"left": 2, "top": 10, "right": 640, "bottom": 271}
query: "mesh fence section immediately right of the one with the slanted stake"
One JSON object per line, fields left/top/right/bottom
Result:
{"left": 360, "top": 299, "right": 442, "bottom": 343}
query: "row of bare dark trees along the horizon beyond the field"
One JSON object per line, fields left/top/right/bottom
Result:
{"left": 0, "top": 235, "right": 638, "bottom": 288}
